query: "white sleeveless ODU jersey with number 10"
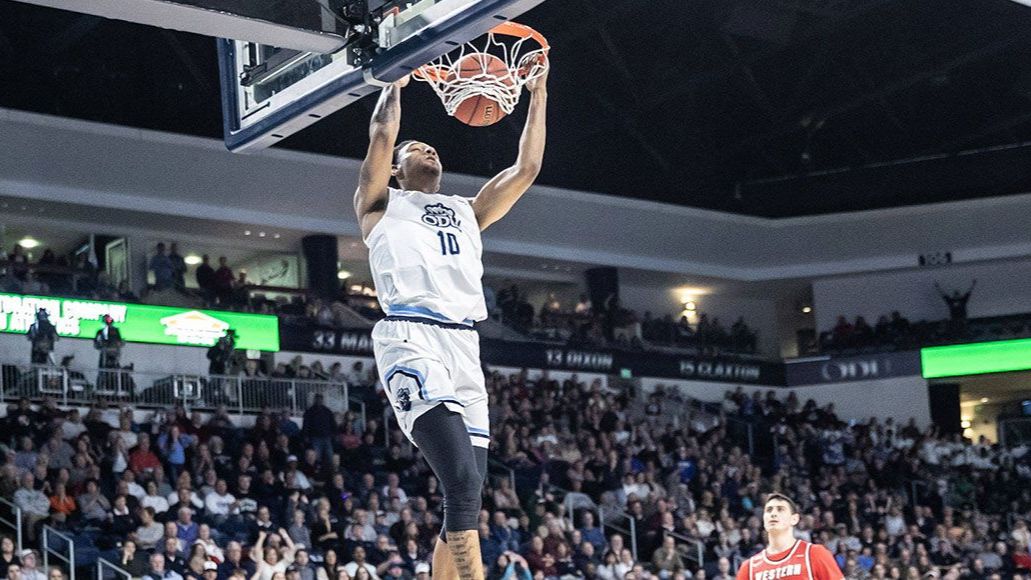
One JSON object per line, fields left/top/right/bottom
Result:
{"left": 365, "top": 187, "right": 487, "bottom": 325}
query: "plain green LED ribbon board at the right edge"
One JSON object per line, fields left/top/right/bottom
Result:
{"left": 920, "top": 338, "right": 1031, "bottom": 379}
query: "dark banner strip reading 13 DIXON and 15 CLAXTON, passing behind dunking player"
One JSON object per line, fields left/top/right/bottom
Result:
{"left": 280, "top": 325, "right": 784, "bottom": 385}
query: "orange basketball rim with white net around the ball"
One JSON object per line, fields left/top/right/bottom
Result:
{"left": 412, "top": 23, "right": 548, "bottom": 116}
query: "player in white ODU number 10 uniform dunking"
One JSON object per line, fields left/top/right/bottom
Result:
{"left": 355, "top": 65, "right": 547, "bottom": 580}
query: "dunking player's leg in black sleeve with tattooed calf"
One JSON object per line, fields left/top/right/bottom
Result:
{"left": 411, "top": 404, "right": 486, "bottom": 580}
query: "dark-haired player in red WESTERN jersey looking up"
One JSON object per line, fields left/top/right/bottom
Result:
{"left": 737, "top": 493, "right": 844, "bottom": 580}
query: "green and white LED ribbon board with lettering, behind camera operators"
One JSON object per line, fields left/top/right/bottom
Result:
{"left": 0, "top": 294, "right": 279, "bottom": 352}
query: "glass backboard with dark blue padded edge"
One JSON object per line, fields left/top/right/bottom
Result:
{"left": 218, "top": 0, "right": 543, "bottom": 151}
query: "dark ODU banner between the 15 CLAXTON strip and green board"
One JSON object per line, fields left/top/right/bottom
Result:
{"left": 785, "top": 350, "right": 920, "bottom": 386}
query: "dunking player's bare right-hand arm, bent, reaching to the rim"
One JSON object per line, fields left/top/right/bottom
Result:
{"left": 472, "top": 65, "right": 547, "bottom": 230}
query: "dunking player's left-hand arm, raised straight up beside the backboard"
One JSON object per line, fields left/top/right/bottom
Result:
{"left": 355, "top": 76, "right": 408, "bottom": 238}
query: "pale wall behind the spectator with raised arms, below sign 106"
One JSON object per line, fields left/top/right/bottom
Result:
{"left": 812, "top": 260, "right": 1031, "bottom": 331}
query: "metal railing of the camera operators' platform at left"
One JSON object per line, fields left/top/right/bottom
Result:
{"left": 0, "top": 365, "right": 350, "bottom": 422}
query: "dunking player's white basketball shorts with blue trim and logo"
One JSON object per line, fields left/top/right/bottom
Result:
{"left": 372, "top": 317, "right": 491, "bottom": 447}
